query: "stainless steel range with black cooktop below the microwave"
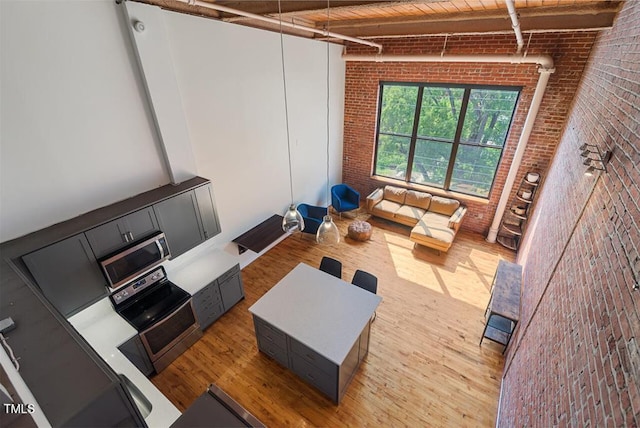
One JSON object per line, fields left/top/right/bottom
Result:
{"left": 110, "top": 266, "right": 202, "bottom": 373}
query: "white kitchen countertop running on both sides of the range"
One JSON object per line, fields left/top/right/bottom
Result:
{"left": 68, "top": 245, "right": 238, "bottom": 428}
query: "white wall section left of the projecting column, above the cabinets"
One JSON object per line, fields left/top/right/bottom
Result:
{"left": 0, "top": 0, "right": 168, "bottom": 241}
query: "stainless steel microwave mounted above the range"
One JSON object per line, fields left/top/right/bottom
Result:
{"left": 100, "top": 232, "right": 171, "bottom": 288}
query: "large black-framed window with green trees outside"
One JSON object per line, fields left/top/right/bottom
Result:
{"left": 374, "top": 83, "right": 520, "bottom": 198}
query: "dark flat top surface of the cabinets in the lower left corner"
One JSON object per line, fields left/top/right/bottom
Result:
{"left": 0, "top": 254, "right": 117, "bottom": 426}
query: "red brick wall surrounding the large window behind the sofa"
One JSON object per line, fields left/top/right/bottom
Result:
{"left": 342, "top": 32, "right": 596, "bottom": 234}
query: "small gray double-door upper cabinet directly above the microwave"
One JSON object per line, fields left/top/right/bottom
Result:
{"left": 86, "top": 207, "right": 159, "bottom": 258}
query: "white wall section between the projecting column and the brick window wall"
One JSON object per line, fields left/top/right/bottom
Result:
{"left": 165, "top": 12, "right": 345, "bottom": 243}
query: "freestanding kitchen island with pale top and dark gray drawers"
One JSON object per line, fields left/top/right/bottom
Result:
{"left": 249, "top": 263, "right": 382, "bottom": 403}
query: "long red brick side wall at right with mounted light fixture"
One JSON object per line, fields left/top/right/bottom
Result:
{"left": 499, "top": 1, "right": 640, "bottom": 427}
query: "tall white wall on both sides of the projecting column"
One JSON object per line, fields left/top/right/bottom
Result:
{"left": 0, "top": 0, "right": 345, "bottom": 251}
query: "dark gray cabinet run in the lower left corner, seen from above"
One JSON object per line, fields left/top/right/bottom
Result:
{"left": 0, "top": 260, "right": 146, "bottom": 427}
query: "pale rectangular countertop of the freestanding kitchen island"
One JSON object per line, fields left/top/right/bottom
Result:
{"left": 249, "top": 263, "right": 382, "bottom": 365}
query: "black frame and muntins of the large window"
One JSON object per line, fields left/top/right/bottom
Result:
{"left": 372, "top": 81, "right": 523, "bottom": 200}
